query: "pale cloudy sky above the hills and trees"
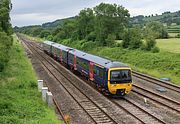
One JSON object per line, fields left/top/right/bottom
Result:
{"left": 11, "top": 0, "right": 180, "bottom": 27}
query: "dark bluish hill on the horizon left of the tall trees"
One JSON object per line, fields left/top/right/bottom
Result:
{"left": 42, "top": 17, "right": 75, "bottom": 28}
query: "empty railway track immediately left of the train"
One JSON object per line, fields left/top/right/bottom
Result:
{"left": 22, "top": 39, "right": 117, "bottom": 124}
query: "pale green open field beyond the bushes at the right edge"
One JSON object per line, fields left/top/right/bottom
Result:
{"left": 156, "top": 38, "right": 180, "bottom": 53}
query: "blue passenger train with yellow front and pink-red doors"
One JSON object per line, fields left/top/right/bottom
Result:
{"left": 41, "top": 41, "right": 132, "bottom": 97}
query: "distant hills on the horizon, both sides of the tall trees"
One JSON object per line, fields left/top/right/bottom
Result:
{"left": 14, "top": 10, "right": 180, "bottom": 33}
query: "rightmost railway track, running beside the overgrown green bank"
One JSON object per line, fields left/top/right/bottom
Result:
{"left": 133, "top": 71, "right": 180, "bottom": 93}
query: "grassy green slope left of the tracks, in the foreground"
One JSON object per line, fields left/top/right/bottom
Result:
{"left": 0, "top": 35, "right": 60, "bottom": 124}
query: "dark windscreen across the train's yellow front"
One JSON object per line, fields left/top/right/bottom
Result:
{"left": 110, "top": 70, "right": 132, "bottom": 84}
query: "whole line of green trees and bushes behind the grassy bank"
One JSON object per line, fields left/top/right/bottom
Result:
{"left": 15, "top": 3, "right": 168, "bottom": 52}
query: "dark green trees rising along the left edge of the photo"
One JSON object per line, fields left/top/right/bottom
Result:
{"left": 0, "top": 0, "right": 13, "bottom": 72}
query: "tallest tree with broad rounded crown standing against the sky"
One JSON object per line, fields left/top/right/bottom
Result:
{"left": 94, "top": 3, "right": 130, "bottom": 45}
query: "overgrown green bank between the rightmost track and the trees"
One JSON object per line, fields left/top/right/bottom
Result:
{"left": 60, "top": 40, "right": 180, "bottom": 84}
